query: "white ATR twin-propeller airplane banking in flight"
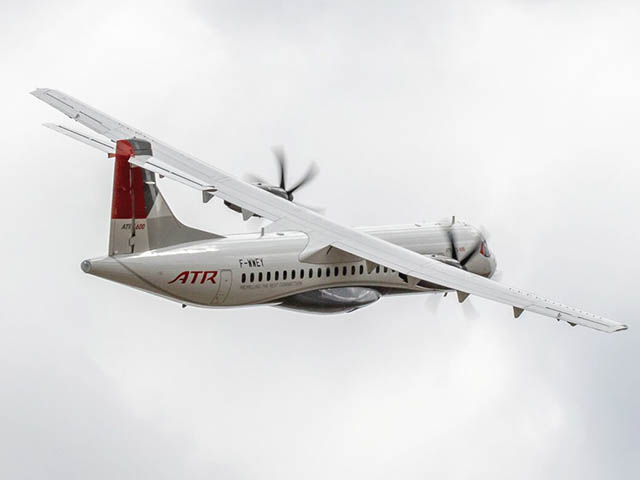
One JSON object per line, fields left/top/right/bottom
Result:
{"left": 31, "top": 88, "right": 628, "bottom": 333}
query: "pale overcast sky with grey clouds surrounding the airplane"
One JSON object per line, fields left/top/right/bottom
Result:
{"left": 0, "top": 0, "right": 640, "bottom": 480}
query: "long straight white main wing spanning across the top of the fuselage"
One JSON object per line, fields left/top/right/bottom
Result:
{"left": 32, "top": 89, "right": 627, "bottom": 332}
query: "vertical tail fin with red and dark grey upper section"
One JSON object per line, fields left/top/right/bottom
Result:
{"left": 109, "top": 139, "right": 221, "bottom": 255}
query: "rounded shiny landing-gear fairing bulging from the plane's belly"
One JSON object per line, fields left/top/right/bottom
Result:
{"left": 278, "top": 287, "right": 382, "bottom": 313}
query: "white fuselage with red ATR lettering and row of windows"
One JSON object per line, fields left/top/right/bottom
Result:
{"left": 82, "top": 224, "right": 496, "bottom": 307}
